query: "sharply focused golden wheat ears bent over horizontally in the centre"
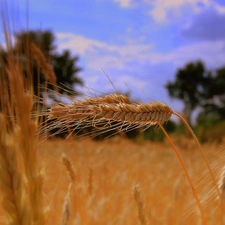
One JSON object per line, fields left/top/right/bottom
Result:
{"left": 48, "top": 94, "right": 173, "bottom": 125}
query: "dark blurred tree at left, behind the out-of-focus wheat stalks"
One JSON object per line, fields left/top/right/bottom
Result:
{"left": 1, "top": 30, "right": 83, "bottom": 99}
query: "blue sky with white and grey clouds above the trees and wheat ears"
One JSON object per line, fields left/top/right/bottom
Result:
{"left": 0, "top": 0, "right": 225, "bottom": 111}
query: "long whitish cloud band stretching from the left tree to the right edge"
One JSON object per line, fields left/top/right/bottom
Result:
{"left": 57, "top": 33, "right": 225, "bottom": 71}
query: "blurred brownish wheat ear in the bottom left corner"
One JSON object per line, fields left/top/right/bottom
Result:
{"left": 0, "top": 113, "right": 26, "bottom": 224}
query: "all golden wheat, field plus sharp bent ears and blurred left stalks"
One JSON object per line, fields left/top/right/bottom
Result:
{"left": 0, "top": 7, "right": 225, "bottom": 225}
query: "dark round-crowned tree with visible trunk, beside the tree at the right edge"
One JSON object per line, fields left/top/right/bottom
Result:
{"left": 166, "top": 61, "right": 211, "bottom": 123}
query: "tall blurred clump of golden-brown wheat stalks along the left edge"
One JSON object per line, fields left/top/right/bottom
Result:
{"left": 0, "top": 8, "right": 55, "bottom": 225}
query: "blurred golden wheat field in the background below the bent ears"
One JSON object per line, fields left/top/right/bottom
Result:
{"left": 27, "top": 137, "right": 225, "bottom": 225}
